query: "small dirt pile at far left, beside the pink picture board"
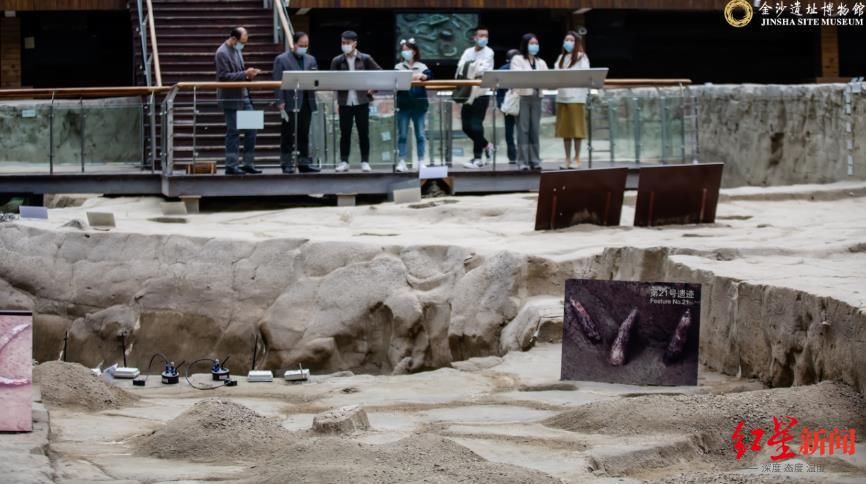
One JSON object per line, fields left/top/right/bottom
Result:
{"left": 33, "top": 361, "right": 138, "bottom": 411}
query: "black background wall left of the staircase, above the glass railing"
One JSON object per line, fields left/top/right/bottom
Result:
{"left": 18, "top": 10, "right": 135, "bottom": 88}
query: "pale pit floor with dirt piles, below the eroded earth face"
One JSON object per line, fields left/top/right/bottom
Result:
{"left": 13, "top": 344, "right": 866, "bottom": 483}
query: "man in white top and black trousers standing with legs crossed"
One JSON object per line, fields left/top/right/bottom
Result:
{"left": 455, "top": 27, "right": 493, "bottom": 169}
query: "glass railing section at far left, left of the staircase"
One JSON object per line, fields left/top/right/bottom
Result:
{"left": 0, "top": 99, "right": 144, "bottom": 173}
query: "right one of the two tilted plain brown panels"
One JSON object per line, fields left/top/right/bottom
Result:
{"left": 634, "top": 163, "right": 724, "bottom": 227}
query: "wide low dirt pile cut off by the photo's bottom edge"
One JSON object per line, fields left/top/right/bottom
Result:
{"left": 246, "top": 434, "right": 560, "bottom": 484}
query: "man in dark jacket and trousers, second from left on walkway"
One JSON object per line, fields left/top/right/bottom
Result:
{"left": 273, "top": 32, "right": 319, "bottom": 173}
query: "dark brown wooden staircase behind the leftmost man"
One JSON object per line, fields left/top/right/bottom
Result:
{"left": 129, "top": 0, "right": 283, "bottom": 169}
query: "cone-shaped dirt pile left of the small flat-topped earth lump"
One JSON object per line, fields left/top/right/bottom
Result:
{"left": 136, "top": 399, "right": 292, "bottom": 462}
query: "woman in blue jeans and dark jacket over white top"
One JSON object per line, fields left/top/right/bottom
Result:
{"left": 394, "top": 39, "right": 433, "bottom": 173}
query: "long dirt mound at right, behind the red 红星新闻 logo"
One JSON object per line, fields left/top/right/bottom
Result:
{"left": 544, "top": 382, "right": 866, "bottom": 476}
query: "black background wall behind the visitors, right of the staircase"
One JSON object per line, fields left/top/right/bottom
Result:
{"left": 309, "top": 9, "right": 866, "bottom": 83}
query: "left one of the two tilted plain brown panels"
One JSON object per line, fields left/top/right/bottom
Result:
{"left": 535, "top": 168, "right": 628, "bottom": 230}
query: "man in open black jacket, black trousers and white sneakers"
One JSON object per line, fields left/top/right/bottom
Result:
{"left": 331, "top": 30, "right": 382, "bottom": 172}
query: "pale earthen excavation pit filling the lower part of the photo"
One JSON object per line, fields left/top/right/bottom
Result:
{"left": 0, "top": 183, "right": 866, "bottom": 482}
